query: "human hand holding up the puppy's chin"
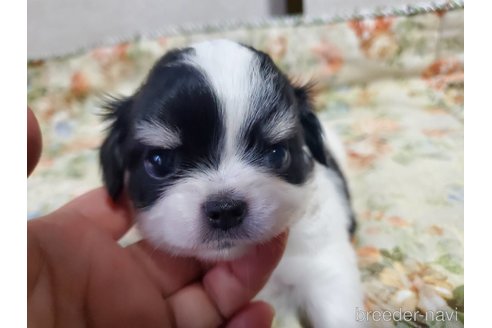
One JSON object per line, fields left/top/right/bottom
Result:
{"left": 27, "top": 107, "right": 286, "bottom": 327}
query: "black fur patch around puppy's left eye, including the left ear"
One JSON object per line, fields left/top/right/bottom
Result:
{"left": 101, "top": 49, "right": 224, "bottom": 208}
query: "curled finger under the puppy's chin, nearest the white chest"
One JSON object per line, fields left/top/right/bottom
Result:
{"left": 203, "top": 233, "right": 287, "bottom": 318}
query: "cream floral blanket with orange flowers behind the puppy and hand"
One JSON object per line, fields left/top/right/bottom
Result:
{"left": 28, "top": 2, "right": 464, "bottom": 327}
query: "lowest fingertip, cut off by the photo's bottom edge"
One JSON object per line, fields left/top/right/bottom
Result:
{"left": 226, "top": 301, "right": 275, "bottom": 328}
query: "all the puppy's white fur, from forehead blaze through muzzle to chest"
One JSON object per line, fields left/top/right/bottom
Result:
{"left": 132, "top": 40, "right": 363, "bottom": 328}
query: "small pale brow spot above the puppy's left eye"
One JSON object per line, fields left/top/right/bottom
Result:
{"left": 135, "top": 120, "right": 181, "bottom": 149}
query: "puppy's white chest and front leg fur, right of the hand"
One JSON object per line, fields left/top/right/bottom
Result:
{"left": 258, "top": 164, "right": 364, "bottom": 328}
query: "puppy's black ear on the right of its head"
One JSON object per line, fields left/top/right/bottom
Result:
{"left": 294, "top": 86, "right": 329, "bottom": 166}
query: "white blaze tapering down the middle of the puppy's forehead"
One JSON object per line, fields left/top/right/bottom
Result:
{"left": 187, "top": 40, "right": 260, "bottom": 154}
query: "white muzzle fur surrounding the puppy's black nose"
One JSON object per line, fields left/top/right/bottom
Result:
{"left": 138, "top": 161, "right": 303, "bottom": 260}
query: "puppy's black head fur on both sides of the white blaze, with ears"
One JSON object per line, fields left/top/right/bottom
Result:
{"left": 100, "top": 43, "right": 355, "bottom": 233}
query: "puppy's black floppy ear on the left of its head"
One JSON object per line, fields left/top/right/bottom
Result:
{"left": 99, "top": 98, "right": 133, "bottom": 200}
